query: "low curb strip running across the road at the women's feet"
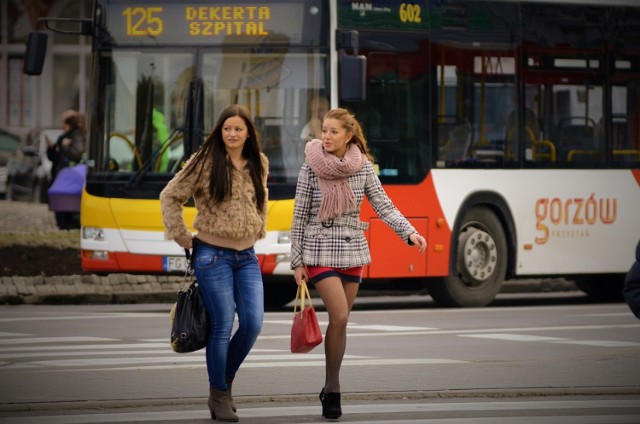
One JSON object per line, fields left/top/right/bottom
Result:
{"left": 0, "top": 386, "right": 640, "bottom": 412}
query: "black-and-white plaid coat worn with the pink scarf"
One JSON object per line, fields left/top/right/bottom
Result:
{"left": 291, "top": 161, "right": 417, "bottom": 269}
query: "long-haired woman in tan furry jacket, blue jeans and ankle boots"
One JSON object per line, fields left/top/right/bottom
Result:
{"left": 160, "top": 105, "right": 269, "bottom": 421}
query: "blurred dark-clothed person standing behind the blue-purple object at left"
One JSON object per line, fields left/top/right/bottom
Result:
{"left": 45, "top": 109, "right": 87, "bottom": 230}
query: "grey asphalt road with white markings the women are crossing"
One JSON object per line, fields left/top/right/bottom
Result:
{"left": 0, "top": 302, "right": 640, "bottom": 422}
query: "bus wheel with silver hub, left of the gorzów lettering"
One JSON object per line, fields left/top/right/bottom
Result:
{"left": 429, "top": 207, "right": 508, "bottom": 307}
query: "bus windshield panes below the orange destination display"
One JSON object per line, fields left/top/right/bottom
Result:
{"left": 96, "top": 50, "right": 326, "bottom": 181}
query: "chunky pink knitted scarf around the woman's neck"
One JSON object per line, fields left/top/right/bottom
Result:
{"left": 304, "top": 140, "right": 367, "bottom": 221}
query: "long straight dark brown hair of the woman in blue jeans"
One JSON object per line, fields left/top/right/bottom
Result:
{"left": 179, "top": 104, "right": 266, "bottom": 210}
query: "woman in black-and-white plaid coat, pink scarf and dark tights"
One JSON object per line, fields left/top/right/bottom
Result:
{"left": 291, "top": 108, "right": 427, "bottom": 419}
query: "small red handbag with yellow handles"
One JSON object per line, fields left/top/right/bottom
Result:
{"left": 291, "top": 281, "right": 322, "bottom": 353}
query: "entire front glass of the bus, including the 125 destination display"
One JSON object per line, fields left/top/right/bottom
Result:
{"left": 87, "top": 1, "right": 330, "bottom": 198}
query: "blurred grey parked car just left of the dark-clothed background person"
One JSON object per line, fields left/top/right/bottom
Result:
{"left": 6, "top": 129, "right": 62, "bottom": 203}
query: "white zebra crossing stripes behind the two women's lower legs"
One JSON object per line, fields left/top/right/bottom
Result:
{"left": 0, "top": 320, "right": 464, "bottom": 373}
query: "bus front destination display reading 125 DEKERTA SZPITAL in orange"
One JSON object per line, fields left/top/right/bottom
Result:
{"left": 108, "top": 2, "right": 304, "bottom": 45}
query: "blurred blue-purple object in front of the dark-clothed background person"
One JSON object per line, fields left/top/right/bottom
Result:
{"left": 48, "top": 163, "right": 87, "bottom": 212}
